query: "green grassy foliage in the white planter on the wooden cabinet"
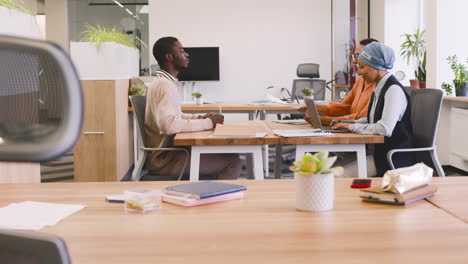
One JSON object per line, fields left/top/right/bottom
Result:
{"left": 80, "top": 24, "right": 142, "bottom": 49}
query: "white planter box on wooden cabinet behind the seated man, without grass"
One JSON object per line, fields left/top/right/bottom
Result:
{"left": 70, "top": 42, "right": 139, "bottom": 80}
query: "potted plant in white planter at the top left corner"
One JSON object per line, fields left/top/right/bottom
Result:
{"left": 0, "top": 0, "right": 39, "bottom": 39}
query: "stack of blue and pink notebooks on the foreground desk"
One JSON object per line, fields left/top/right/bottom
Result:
{"left": 162, "top": 181, "right": 247, "bottom": 207}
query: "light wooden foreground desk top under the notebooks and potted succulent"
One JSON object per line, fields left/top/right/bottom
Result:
{"left": 0, "top": 178, "right": 468, "bottom": 264}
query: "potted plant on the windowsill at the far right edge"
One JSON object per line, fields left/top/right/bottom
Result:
{"left": 442, "top": 55, "right": 468, "bottom": 96}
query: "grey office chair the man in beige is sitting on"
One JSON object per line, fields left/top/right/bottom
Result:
{"left": 129, "top": 95, "right": 189, "bottom": 181}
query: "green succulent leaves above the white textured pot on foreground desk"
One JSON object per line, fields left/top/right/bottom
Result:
{"left": 289, "top": 151, "right": 344, "bottom": 176}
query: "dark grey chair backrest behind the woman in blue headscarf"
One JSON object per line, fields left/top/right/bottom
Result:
{"left": 410, "top": 88, "right": 443, "bottom": 148}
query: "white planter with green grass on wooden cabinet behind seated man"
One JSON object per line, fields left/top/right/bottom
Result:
{"left": 70, "top": 25, "right": 141, "bottom": 80}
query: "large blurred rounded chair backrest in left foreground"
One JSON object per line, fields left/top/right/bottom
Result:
{"left": 0, "top": 36, "right": 83, "bottom": 162}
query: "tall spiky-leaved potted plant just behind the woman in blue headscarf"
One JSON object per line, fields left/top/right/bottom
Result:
{"left": 400, "top": 28, "right": 426, "bottom": 88}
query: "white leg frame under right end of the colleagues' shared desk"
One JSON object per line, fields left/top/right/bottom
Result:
{"left": 296, "top": 144, "right": 367, "bottom": 178}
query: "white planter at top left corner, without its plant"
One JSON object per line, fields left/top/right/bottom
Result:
{"left": 0, "top": 6, "right": 39, "bottom": 39}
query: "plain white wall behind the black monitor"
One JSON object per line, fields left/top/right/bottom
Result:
{"left": 149, "top": 0, "right": 331, "bottom": 101}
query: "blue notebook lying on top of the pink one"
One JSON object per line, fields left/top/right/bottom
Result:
{"left": 166, "top": 181, "right": 247, "bottom": 199}
